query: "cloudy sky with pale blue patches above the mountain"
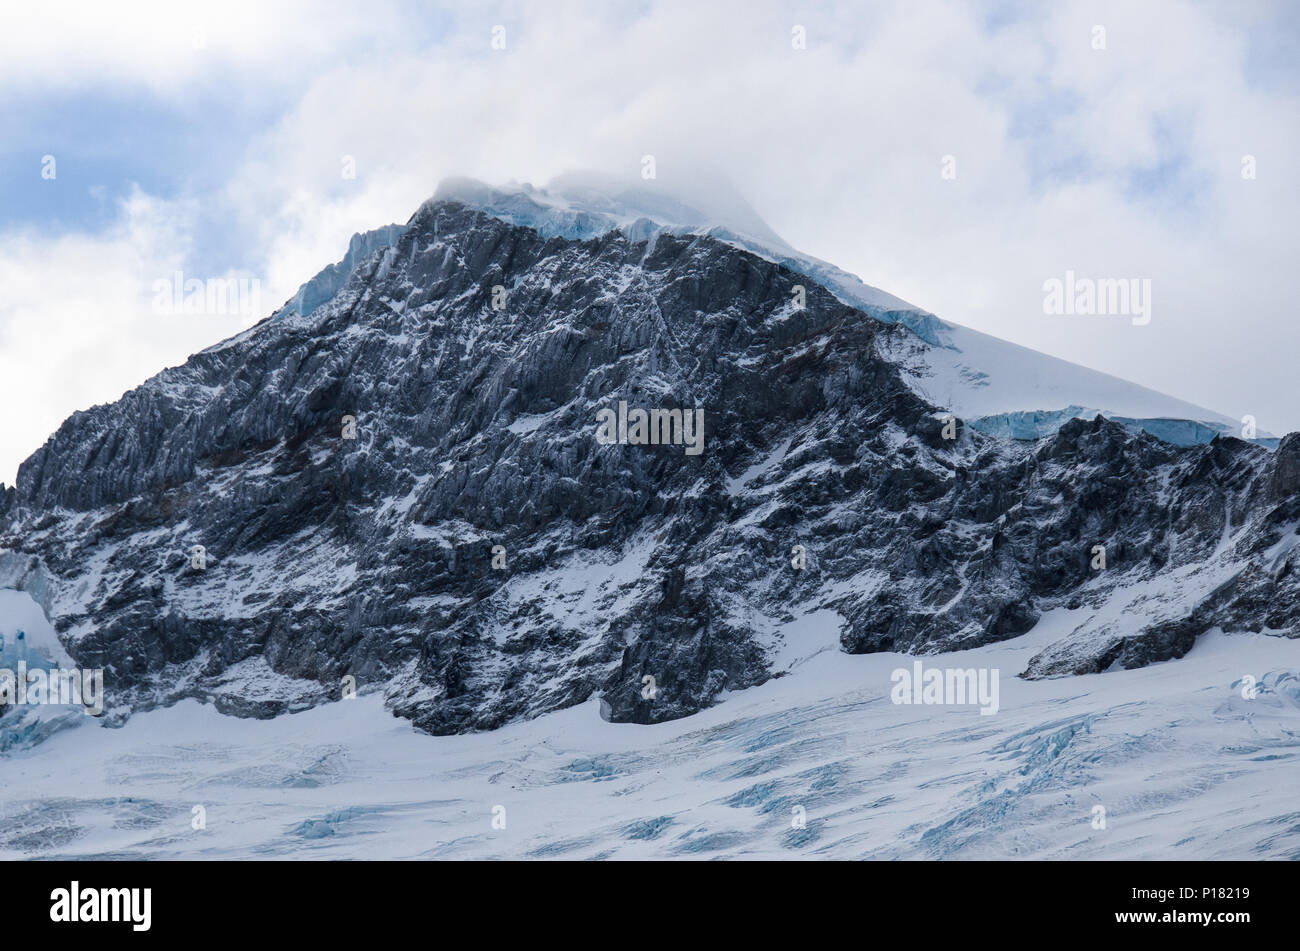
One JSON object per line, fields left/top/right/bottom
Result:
{"left": 0, "top": 0, "right": 1300, "bottom": 482}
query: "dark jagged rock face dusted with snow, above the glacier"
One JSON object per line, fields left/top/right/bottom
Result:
{"left": 0, "top": 201, "right": 1300, "bottom": 733}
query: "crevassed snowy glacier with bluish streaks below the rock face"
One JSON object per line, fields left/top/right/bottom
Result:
{"left": 0, "top": 611, "right": 1300, "bottom": 859}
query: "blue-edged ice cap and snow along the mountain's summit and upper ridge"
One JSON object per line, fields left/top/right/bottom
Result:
{"left": 286, "top": 171, "right": 1278, "bottom": 448}
